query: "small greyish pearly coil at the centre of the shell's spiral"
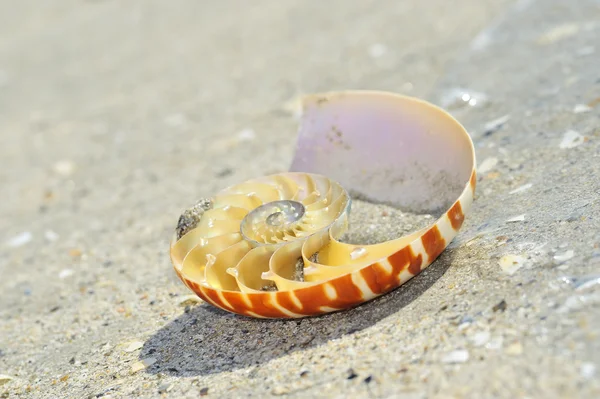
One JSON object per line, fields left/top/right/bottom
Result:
{"left": 241, "top": 200, "right": 306, "bottom": 245}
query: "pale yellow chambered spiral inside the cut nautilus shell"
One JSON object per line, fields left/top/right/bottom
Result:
{"left": 172, "top": 173, "right": 350, "bottom": 293}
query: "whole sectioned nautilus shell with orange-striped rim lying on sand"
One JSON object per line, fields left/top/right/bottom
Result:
{"left": 171, "top": 91, "right": 476, "bottom": 318}
